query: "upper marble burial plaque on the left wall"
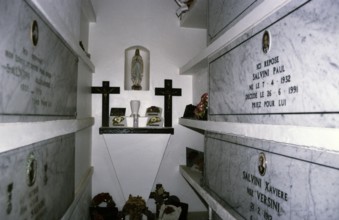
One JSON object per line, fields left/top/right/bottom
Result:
{"left": 0, "top": 0, "right": 77, "bottom": 120}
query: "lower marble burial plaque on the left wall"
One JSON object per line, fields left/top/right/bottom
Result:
{"left": 0, "top": 134, "right": 75, "bottom": 220}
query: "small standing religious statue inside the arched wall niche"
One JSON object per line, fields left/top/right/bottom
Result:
{"left": 131, "top": 49, "right": 144, "bottom": 90}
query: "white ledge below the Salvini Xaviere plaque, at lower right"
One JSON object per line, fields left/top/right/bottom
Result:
{"left": 180, "top": 166, "right": 242, "bottom": 220}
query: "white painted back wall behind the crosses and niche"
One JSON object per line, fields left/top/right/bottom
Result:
{"left": 89, "top": 0, "right": 206, "bottom": 211}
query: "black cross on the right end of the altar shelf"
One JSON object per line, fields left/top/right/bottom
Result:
{"left": 155, "top": 79, "right": 181, "bottom": 127}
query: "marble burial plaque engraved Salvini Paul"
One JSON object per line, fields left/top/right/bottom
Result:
{"left": 209, "top": 0, "right": 339, "bottom": 127}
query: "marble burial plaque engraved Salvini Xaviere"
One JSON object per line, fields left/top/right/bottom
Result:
{"left": 204, "top": 133, "right": 339, "bottom": 220}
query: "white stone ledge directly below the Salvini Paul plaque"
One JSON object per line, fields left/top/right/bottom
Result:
{"left": 179, "top": 118, "right": 339, "bottom": 151}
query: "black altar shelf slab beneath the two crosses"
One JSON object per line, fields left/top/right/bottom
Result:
{"left": 99, "top": 127, "right": 174, "bottom": 134}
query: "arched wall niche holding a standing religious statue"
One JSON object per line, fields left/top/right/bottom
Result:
{"left": 125, "top": 46, "right": 150, "bottom": 91}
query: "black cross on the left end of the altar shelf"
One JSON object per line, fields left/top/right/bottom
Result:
{"left": 92, "top": 81, "right": 120, "bottom": 127}
